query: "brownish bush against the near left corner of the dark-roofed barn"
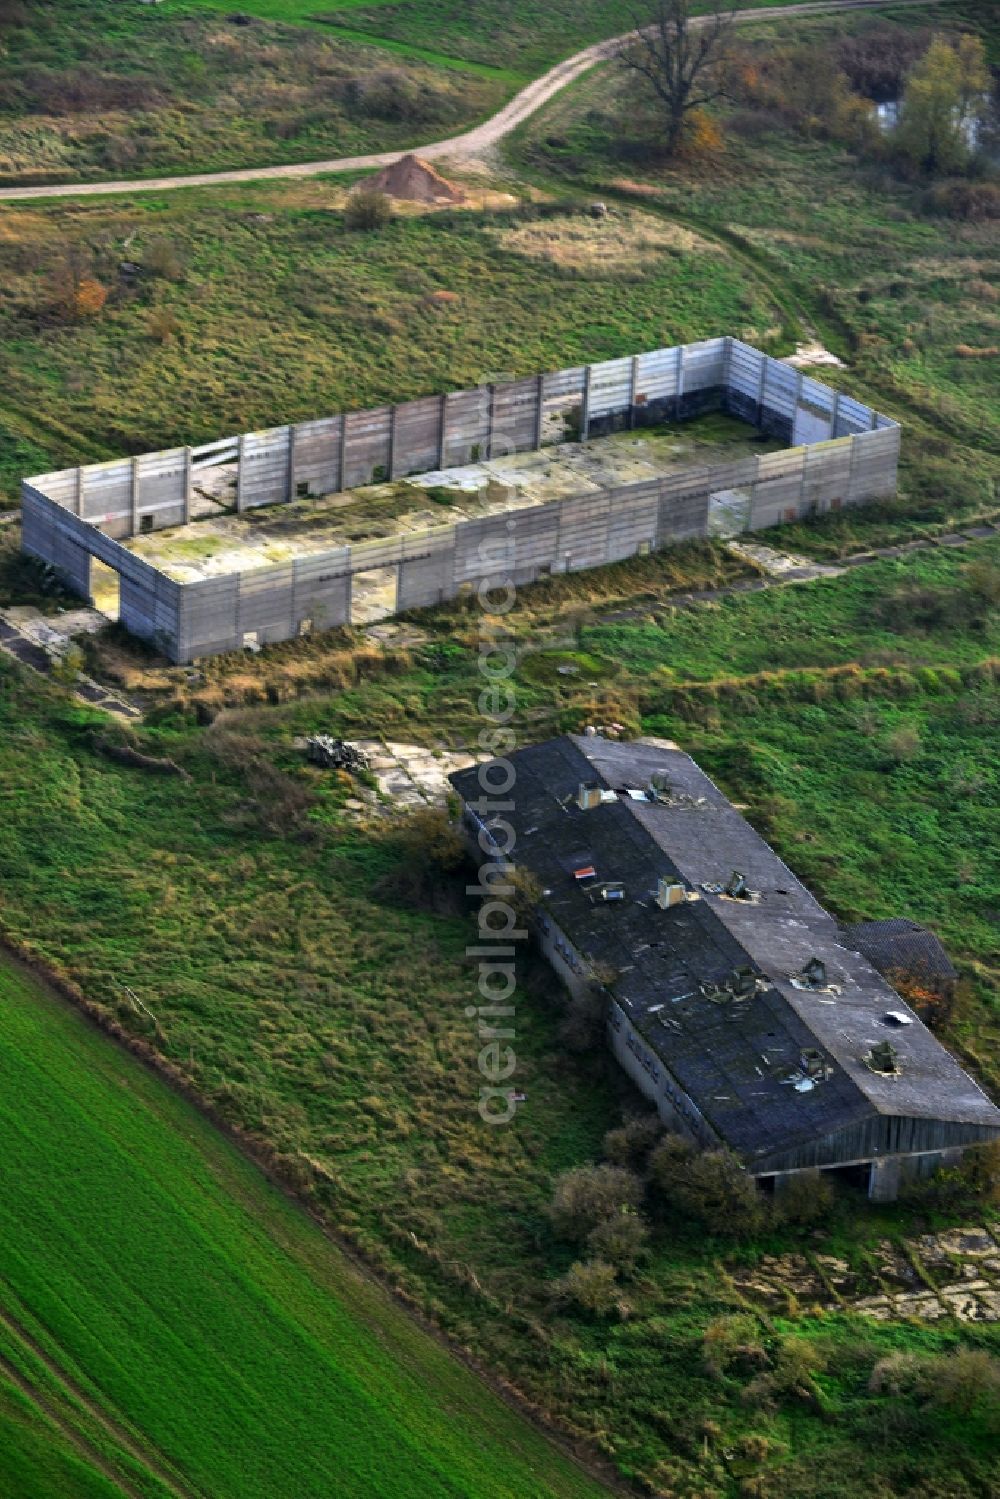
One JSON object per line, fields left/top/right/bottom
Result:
{"left": 651, "top": 1135, "right": 766, "bottom": 1238}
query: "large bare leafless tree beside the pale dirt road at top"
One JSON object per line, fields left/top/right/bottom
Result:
{"left": 622, "top": 0, "right": 736, "bottom": 156}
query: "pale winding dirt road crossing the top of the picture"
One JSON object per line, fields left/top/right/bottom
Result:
{"left": 0, "top": 0, "right": 930, "bottom": 202}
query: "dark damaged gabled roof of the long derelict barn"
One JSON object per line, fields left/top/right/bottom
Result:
{"left": 451, "top": 735, "right": 1000, "bottom": 1160}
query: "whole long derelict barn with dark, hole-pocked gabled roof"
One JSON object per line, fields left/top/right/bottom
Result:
{"left": 451, "top": 735, "right": 1000, "bottom": 1201}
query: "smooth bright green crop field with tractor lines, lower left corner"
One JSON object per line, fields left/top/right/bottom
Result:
{"left": 0, "top": 964, "right": 604, "bottom": 1499}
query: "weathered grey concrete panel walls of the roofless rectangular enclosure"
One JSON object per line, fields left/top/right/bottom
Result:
{"left": 22, "top": 339, "right": 900, "bottom": 661}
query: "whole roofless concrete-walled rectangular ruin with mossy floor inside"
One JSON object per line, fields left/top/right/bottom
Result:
{"left": 21, "top": 337, "right": 900, "bottom": 661}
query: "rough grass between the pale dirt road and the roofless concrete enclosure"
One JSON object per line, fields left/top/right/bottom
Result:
{"left": 0, "top": 181, "right": 777, "bottom": 499}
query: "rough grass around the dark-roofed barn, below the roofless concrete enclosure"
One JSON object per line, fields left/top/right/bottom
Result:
{"left": 0, "top": 544, "right": 1000, "bottom": 1499}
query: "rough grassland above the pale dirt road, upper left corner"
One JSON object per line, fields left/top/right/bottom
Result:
{"left": 0, "top": 0, "right": 503, "bottom": 186}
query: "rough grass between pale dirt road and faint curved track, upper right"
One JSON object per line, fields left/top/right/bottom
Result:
{"left": 511, "top": 6, "right": 1000, "bottom": 452}
